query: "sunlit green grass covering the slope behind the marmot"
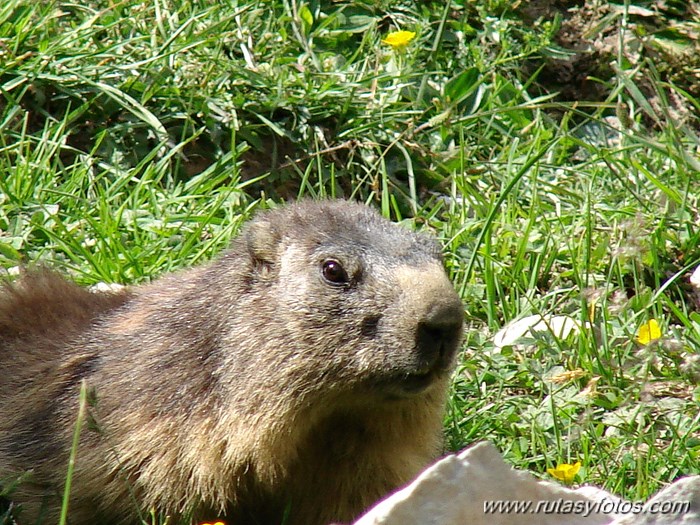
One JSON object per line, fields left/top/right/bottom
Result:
{"left": 0, "top": 0, "right": 700, "bottom": 522}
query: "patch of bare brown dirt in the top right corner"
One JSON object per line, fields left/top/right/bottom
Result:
{"left": 517, "top": 0, "right": 700, "bottom": 123}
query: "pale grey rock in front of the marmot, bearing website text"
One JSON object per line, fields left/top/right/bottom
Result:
{"left": 355, "top": 443, "right": 700, "bottom": 525}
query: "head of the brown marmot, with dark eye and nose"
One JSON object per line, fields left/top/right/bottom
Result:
{"left": 216, "top": 201, "right": 464, "bottom": 399}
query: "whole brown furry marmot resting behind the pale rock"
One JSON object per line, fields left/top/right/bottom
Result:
{"left": 0, "top": 201, "right": 464, "bottom": 525}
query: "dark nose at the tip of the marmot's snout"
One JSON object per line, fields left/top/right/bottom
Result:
{"left": 416, "top": 298, "right": 464, "bottom": 369}
